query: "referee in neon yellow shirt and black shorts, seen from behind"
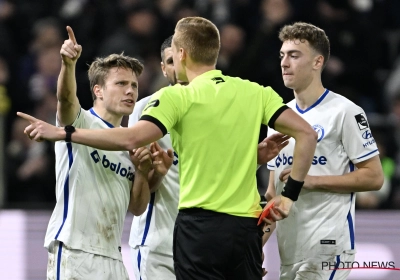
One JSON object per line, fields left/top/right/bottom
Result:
{"left": 18, "top": 17, "right": 317, "bottom": 280}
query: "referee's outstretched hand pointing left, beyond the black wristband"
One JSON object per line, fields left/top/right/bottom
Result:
{"left": 17, "top": 112, "right": 65, "bottom": 142}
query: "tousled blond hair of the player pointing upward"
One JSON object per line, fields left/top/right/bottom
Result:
{"left": 88, "top": 53, "right": 143, "bottom": 101}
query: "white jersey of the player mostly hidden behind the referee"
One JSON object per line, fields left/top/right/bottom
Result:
{"left": 128, "top": 96, "right": 179, "bottom": 256}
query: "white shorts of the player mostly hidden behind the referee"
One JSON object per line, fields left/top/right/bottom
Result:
{"left": 131, "top": 246, "right": 176, "bottom": 280}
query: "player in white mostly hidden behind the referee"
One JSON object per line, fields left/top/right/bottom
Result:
{"left": 128, "top": 36, "right": 179, "bottom": 280}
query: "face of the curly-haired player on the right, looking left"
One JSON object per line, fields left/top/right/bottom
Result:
{"left": 280, "top": 40, "right": 317, "bottom": 91}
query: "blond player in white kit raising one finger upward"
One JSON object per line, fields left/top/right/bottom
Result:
{"left": 45, "top": 27, "right": 152, "bottom": 279}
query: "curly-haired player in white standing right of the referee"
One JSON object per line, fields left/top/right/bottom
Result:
{"left": 266, "top": 22, "right": 383, "bottom": 280}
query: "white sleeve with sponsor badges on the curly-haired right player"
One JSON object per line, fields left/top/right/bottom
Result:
{"left": 342, "top": 105, "right": 379, "bottom": 163}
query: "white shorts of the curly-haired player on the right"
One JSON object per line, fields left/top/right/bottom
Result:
{"left": 279, "top": 251, "right": 355, "bottom": 280}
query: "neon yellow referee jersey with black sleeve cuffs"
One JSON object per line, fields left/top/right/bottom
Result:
{"left": 141, "top": 70, "right": 284, "bottom": 217}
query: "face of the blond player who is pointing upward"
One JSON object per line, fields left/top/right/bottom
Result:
{"left": 97, "top": 67, "right": 138, "bottom": 116}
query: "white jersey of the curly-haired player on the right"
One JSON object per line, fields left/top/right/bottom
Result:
{"left": 268, "top": 90, "right": 379, "bottom": 265}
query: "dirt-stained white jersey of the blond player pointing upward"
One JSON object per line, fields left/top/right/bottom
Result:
{"left": 45, "top": 108, "right": 134, "bottom": 260}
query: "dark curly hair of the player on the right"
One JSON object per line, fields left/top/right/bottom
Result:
{"left": 279, "top": 22, "right": 330, "bottom": 68}
